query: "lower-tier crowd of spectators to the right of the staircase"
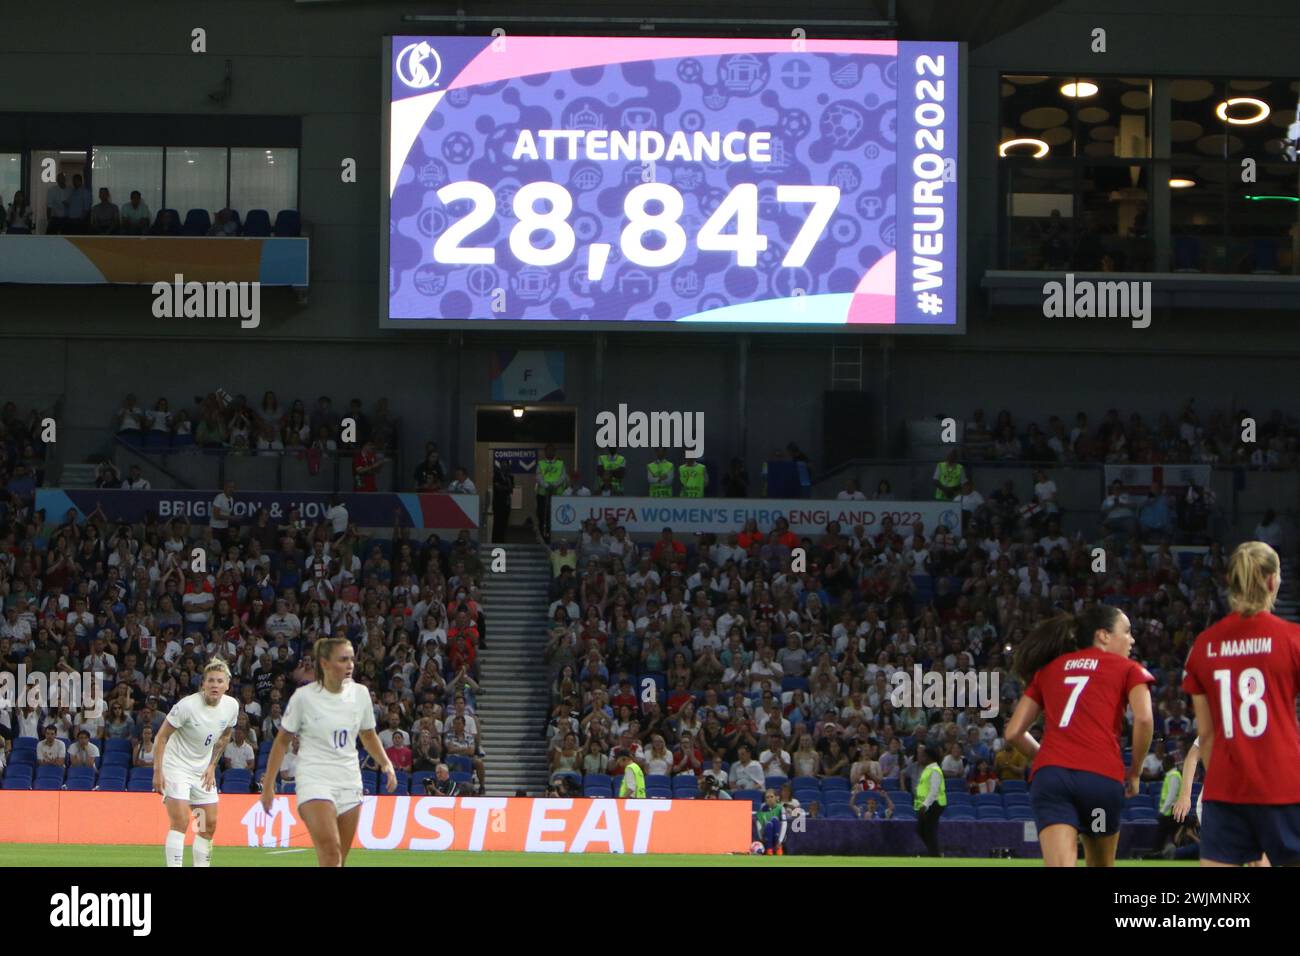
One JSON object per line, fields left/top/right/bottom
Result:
{"left": 546, "top": 494, "right": 1226, "bottom": 806}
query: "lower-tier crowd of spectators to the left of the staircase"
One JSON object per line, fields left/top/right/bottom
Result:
{"left": 0, "top": 488, "right": 486, "bottom": 792}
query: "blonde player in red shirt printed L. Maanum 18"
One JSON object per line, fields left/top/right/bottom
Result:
{"left": 1183, "top": 541, "right": 1300, "bottom": 866}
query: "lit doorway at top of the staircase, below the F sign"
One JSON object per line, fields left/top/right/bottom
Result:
{"left": 473, "top": 405, "right": 579, "bottom": 542}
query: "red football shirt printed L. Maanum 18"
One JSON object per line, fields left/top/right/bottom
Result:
{"left": 1183, "top": 614, "right": 1300, "bottom": 804}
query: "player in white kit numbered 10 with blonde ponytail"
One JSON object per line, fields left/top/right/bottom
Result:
{"left": 261, "top": 637, "right": 398, "bottom": 866}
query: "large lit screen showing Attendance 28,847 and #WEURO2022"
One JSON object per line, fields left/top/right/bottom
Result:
{"left": 381, "top": 35, "right": 962, "bottom": 332}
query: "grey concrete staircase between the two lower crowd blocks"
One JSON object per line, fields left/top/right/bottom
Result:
{"left": 478, "top": 544, "right": 551, "bottom": 796}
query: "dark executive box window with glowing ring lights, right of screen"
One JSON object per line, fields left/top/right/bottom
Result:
{"left": 998, "top": 75, "right": 1300, "bottom": 274}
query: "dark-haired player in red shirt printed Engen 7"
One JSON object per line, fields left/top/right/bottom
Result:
{"left": 1006, "top": 605, "right": 1156, "bottom": 866}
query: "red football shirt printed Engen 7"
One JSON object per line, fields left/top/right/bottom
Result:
{"left": 1024, "top": 648, "right": 1156, "bottom": 782}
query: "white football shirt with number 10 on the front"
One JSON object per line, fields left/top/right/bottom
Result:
{"left": 281, "top": 680, "right": 374, "bottom": 790}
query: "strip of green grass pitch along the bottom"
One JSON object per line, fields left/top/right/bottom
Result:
{"left": 0, "top": 843, "right": 1196, "bottom": 869}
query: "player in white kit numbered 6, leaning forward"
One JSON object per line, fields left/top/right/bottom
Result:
{"left": 153, "top": 661, "right": 239, "bottom": 866}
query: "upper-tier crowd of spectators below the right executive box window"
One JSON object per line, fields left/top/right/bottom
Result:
{"left": 962, "top": 401, "right": 1300, "bottom": 470}
